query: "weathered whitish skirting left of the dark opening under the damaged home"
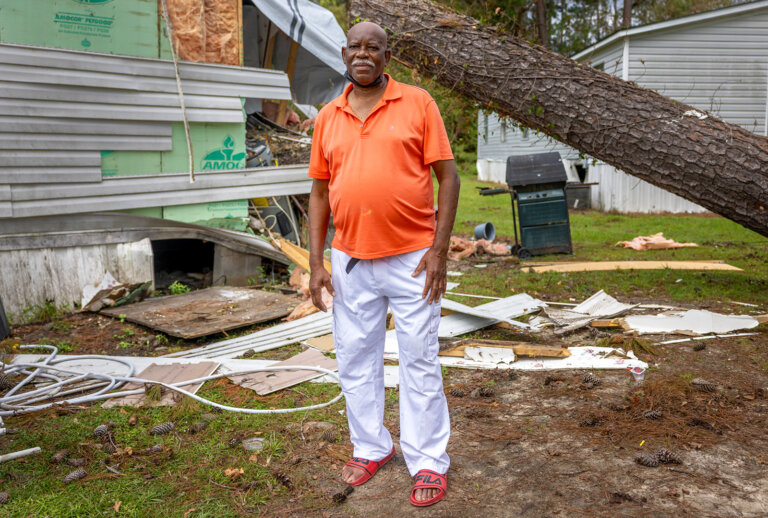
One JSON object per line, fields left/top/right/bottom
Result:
{"left": 0, "top": 239, "right": 154, "bottom": 314}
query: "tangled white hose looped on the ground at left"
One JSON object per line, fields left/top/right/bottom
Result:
{"left": 0, "top": 345, "right": 344, "bottom": 417}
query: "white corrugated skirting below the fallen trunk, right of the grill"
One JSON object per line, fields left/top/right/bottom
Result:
{"left": 587, "top": 163, "right": 707, "bottom": 213}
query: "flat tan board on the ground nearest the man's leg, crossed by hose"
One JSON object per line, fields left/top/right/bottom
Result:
{"left": 229, "top": 349, "right": 338, "bottom": 396}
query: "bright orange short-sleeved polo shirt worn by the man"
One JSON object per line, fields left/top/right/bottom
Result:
{"left": 309, "top": 75, "right": 453, "bottom": 259}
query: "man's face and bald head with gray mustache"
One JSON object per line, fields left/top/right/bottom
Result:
{"left": 341, "top": 22, "right": 390, "bottom": 85}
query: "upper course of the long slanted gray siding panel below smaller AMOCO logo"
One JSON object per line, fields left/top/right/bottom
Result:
{"left": 12, "top": 165, "right": 309, "bottom": 201}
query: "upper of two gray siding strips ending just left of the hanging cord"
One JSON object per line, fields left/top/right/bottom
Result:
{"left": 0, "top": 116, "right": 173, "bottom": 137}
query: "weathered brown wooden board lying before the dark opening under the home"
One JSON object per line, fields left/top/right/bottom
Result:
{"left": 101, "top": 286, "right": 298, "bottom": 339}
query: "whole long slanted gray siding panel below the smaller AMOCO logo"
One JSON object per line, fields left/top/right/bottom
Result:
{"left": 5, "top": 165, "right": 312, "bottom": 218}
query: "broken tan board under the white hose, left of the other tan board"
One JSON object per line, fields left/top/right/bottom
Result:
{"left": 101, "top": 361, "right": 219, "bottom": 408}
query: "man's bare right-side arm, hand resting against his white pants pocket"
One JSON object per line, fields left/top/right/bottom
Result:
{"left": 413, "top": 160, "right": 461, "bottom": 304}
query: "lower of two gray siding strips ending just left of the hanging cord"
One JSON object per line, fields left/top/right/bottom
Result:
{"left": 0, "top": 133, "right": 173, "bottom": 150}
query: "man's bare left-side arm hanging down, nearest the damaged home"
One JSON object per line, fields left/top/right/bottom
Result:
{"left": 309, "top": 178, "right": 336, "bottom": 311}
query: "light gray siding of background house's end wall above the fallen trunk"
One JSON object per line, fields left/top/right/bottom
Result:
{"left": 630, "top": 8, "right": 768, "bottom": 134}
